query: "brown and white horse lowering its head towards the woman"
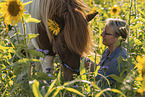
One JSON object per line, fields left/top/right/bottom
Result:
{"left": 24, "top": 0, "right": 98, "bottom": 81}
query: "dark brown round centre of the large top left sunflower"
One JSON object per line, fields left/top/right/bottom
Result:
{"left": 8, "top": 1, "right": 20, "bottom": 16}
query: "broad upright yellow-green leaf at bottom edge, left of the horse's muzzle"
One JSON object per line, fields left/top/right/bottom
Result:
{"left": 32, "top": 80, "right": 42, "bottom": 97}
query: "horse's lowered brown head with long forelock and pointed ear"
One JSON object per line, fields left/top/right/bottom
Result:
{"left": 53, "top": 10, "right": 98, "bottom": 81}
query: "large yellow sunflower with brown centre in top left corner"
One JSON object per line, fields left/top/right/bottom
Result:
{"left": 0, "top": 0, "right": 25, "bottom": 25}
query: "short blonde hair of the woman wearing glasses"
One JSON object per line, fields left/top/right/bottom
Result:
{"left": 106, "top": 18, "right": 127, "bottom": 40}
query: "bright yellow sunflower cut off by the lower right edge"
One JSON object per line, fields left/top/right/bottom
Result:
{"left": 135, "top": 56, "right": 145, "bottom": 95}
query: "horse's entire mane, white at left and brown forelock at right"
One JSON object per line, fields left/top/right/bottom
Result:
{"left": 27, "top": 0, "right": 91, "bottom": 55}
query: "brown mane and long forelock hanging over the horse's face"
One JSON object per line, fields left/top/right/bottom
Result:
{"left": 48, "top": 0, "right": 91, "bottom": 55}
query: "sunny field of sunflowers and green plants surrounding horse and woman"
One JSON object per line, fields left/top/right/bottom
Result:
{"left": 0, "top": 0, "right": 145, "bottom": 97}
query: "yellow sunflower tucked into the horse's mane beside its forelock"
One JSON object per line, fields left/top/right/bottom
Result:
{"left": 47, "top": 19, "right": 60, "bottom": 35}
